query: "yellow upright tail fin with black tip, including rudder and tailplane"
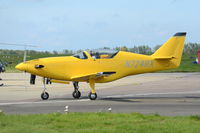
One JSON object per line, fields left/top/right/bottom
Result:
{"left": 151, "top": 32, "right": 186, "bottom": 67}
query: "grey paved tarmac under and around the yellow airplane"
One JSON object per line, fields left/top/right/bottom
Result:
{"left": 0, "top": 73, "right": 200, "bottom": 116}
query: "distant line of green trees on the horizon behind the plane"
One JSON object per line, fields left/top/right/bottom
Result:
{"left": 0, "top": 43, "right": 200, "bottom": 57}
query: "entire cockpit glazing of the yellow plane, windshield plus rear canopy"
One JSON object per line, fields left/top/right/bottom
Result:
{"left": 74, "top": 49, "right": 119, "bottom": 59}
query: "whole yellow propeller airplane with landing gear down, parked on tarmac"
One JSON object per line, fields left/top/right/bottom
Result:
{"left": 16, "top": 32, "right": 186, "bottom": 100}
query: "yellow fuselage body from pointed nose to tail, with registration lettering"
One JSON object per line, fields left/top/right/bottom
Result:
{"left": 16, "top": 51, "right": 176, "bottom": 83}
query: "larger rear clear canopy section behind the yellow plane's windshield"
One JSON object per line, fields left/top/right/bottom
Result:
{"left": 88, "top": 49, "right": 118, "bottom": 59}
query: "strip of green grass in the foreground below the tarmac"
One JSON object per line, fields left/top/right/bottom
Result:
{"left": 0, "top": 113, "right": 200, "bottom": 133}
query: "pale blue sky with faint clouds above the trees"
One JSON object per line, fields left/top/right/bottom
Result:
{"left": 0, "top": 0, "right": 200, "bottom": 51}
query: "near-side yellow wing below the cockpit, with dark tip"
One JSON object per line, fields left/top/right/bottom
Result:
{"left": 71, "top": 72, "right": 116, "bottom": 80}
